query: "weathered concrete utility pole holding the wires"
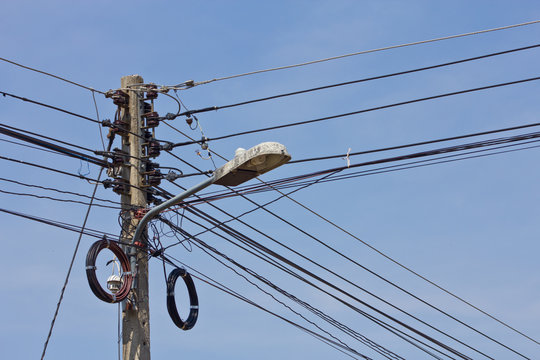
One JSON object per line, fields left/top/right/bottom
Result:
{"left": 120, "top": 75, "right": 150, "bottom": 360}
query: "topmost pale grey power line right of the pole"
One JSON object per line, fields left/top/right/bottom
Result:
{"left": 164, "top": 20, "right": 540, "bottom": 89}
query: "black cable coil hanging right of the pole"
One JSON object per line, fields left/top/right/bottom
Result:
{"left": 167, "top": 268, "right": 199, "bottom": 330}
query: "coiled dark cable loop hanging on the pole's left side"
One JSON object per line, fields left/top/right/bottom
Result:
{"left": 86, "top": 237, "right": 133, "bottom": 303}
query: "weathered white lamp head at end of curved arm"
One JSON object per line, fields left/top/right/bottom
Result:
{"left": 214, "top": 142, "right": 291, "bottom": 186}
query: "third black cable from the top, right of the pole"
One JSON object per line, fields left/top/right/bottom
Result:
{"left": 173, "top": 76, "right": 540, "bottom": 147}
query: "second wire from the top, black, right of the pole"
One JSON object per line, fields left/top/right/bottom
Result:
{"left": 177, "top": 44, "right": 540, "bottom": 116}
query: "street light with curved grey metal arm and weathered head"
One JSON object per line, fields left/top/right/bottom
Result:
{"left": 132, "top": 142, "right": 291, "bottom": 244}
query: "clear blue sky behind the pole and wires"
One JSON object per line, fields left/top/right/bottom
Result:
{"left": 0, "top": 0, "right": 540, "bottom": 360}
